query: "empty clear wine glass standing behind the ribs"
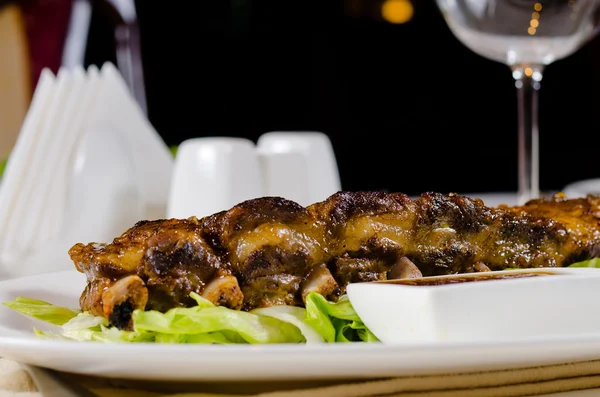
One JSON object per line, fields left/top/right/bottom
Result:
{"left": 436, "top": 0, "right": 600, "bottom": 204}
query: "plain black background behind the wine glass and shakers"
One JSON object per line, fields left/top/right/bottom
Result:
{"left": 87, "top": 0, "right": 600, "bottom": 194}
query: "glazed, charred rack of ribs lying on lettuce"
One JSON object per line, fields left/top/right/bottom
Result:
{"left": 69, "top": 192, "right": 600, "bottom": 329}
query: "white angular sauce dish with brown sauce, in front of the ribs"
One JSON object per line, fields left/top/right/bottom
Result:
{"left": 347, "top": 268, "right": 600, "bottom": 344}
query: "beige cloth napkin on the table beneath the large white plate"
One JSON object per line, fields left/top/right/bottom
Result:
{"left": 0, "top": 358, "right": 600, "bottom": 397}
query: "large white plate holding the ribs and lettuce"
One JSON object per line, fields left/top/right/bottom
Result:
{"left": 0, "top": 271, "right": 600, "bottom": 381}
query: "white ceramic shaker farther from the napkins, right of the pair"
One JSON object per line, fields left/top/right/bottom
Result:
{"left": 257, "top": 131, "right": 341, "bottom": 206}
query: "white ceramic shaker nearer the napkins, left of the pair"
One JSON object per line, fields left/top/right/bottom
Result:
{"left": 167, "top": 137, "right": 264, "bottom": 218}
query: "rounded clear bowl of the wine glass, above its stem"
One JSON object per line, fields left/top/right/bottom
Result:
{"left": 438, "top": 0, "right": 598, "bottom": 66}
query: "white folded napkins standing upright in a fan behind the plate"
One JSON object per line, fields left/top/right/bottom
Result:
{"left": 0, "top": 63, "right": 173, "bottom": 279}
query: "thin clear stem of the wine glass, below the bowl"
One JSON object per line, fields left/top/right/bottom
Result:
{"left": 512, "top": 65, "right": 543, "bottom": 204}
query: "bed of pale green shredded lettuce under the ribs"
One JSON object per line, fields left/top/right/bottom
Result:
{"left": 4, "top": 293, "right": 378, "bottom": 344}
